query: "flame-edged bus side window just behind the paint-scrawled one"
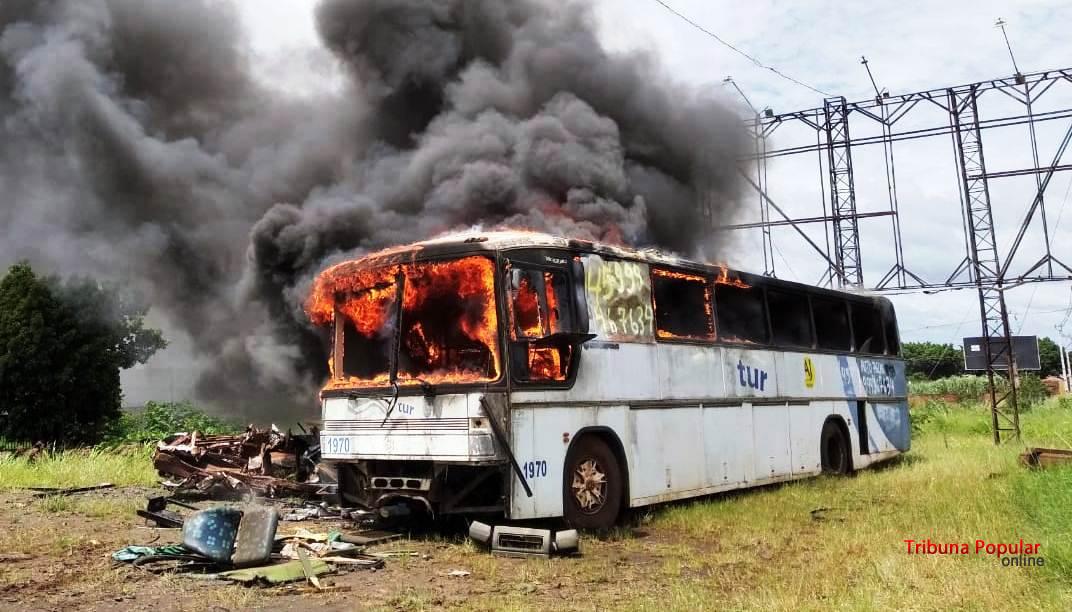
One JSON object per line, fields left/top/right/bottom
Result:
{"left": 652, "top": 268, "right": 715, "bottom": 340}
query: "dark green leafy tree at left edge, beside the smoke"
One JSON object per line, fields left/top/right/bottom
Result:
{"left": 0, "top": 263, "right": 166, "bottom": 442}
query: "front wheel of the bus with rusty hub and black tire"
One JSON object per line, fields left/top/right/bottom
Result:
{"left": 562, "top": 435, "right": 625, "bottom": 529}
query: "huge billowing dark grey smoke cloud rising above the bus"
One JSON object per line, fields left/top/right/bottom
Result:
{"left": 0, "top": 0, "right": 743, "bottom": 412}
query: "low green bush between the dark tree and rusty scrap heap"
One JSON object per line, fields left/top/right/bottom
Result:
{"left": 105, "top": 402, "right": 241, "bottom": 445}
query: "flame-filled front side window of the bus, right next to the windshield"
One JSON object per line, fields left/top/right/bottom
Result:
{"left": 509, "top": 268, "right": 574, "bottom": 383}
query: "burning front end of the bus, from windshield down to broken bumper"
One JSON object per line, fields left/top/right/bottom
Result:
{"left": 307, "top": 255, "right": 508, "bottom": 513}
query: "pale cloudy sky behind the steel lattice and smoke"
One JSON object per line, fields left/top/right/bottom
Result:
{"left": 221, "top": 0, "right": 1072, "bottom": 351}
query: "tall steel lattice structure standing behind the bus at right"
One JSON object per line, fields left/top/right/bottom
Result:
{"left": 717, "top": 66, "right": 1072, "bottom": 443}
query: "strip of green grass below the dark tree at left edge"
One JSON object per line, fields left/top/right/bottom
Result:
{"left": 0, "top": 447, "right": 157, "bottom": 490}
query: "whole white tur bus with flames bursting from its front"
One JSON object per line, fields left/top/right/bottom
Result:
{"left": 307, "top": 232, "right": 910, "bottom": 528}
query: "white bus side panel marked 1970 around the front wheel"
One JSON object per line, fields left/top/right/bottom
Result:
{"left": 509, "top": 404, "right": 634, "bottom": 520}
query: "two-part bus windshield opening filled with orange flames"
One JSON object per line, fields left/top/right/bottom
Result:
{"left": 332, "top": 256, "right": 501, "bottom": 387}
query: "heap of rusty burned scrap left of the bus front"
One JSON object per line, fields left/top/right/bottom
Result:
{"left": 153, "top": 426, "right": 325, "bottom": 499}
